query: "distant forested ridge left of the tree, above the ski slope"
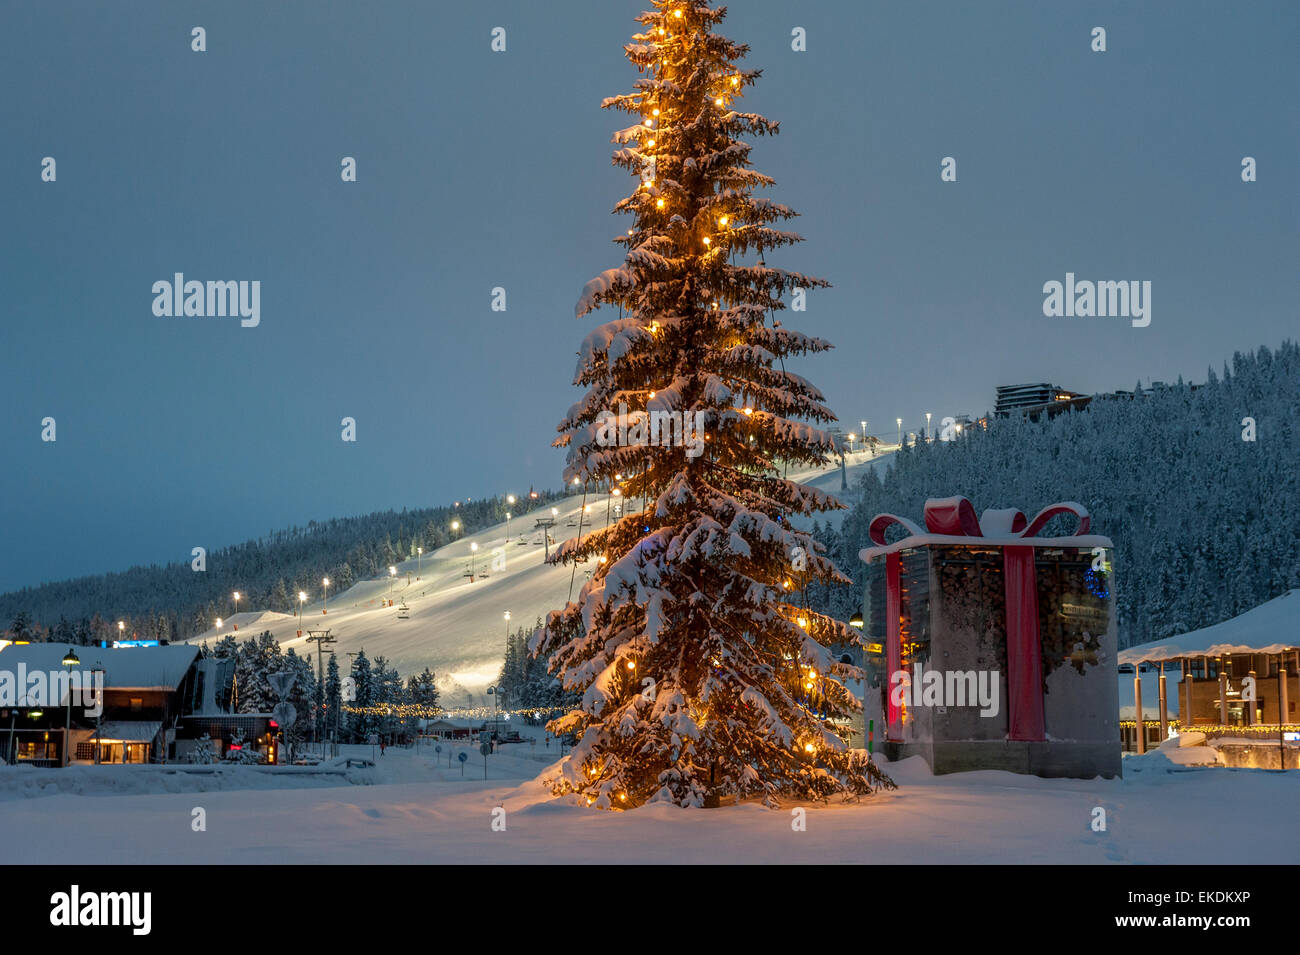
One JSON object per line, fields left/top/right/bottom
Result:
{"left": 0, "top": 491, "right": 563, "bottom": 644}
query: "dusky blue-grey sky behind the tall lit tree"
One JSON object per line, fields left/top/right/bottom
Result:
{"left": 0, "top": 0, "right": 1300, "bottom": 590}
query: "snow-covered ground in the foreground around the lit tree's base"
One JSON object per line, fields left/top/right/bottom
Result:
{"left": 0, "top": 730, "right": 1300, "bottom": 865}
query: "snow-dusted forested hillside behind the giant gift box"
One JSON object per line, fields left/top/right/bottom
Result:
{"left": 813, "top": 342, "right": 1300, "bottom": 647}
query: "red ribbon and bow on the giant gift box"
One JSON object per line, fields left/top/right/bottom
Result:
{"left": 868, "top": 498, "right": 1092, "bottom": 742}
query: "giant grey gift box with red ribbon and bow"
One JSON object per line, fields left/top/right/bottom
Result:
{"left": 859, "top": 498, "right": 1121, "bottom": 778}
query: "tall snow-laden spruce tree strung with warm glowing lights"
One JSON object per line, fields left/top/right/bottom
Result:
{"left": 529, "top": 0, "right": 893, "bottom": 808}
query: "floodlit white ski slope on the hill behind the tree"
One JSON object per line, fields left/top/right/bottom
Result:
{"left": 189, "top": 452, "right": 889, "bottom": 707}
